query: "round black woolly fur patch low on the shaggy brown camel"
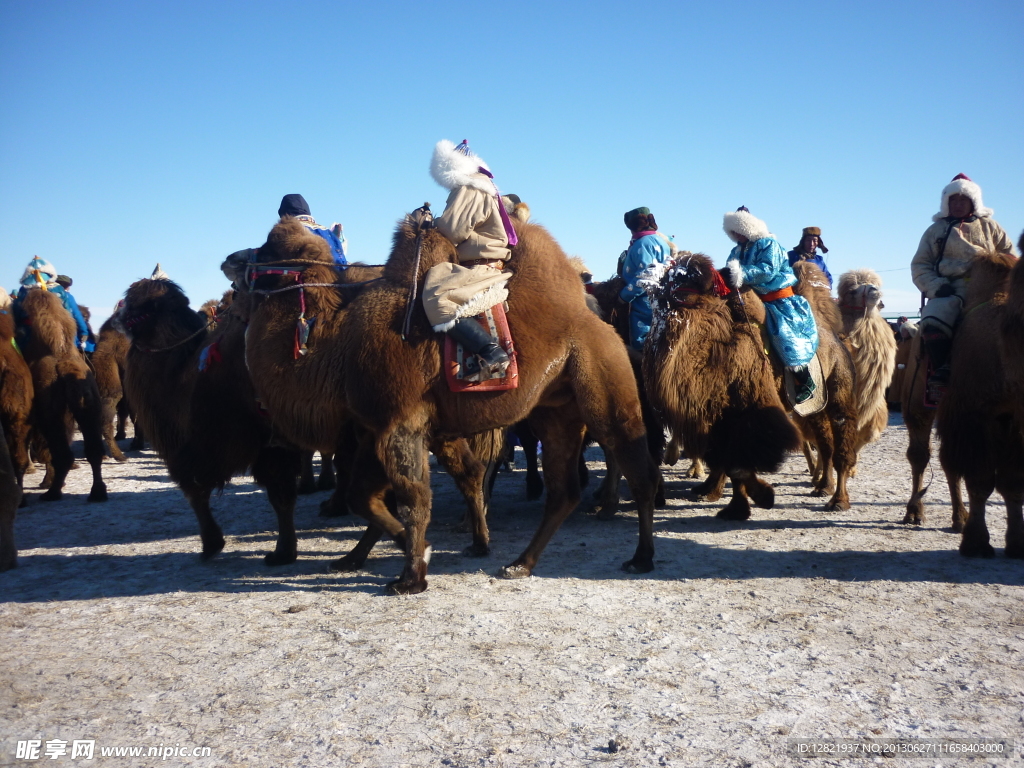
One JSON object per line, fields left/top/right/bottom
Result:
{"left": 706, "top": 406, "right": 800, "bottom": 472}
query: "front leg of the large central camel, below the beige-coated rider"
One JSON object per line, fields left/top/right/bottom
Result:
{"left": 377, "top": 423, "right": 431, "bottom": 595}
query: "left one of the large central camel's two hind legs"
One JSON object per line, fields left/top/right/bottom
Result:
{"left": 499, "top": 408, "right": 584, "bottom": 579}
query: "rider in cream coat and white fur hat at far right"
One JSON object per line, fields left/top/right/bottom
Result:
{"left": 910, "top": 173, "right": 1013, "bottom": 391}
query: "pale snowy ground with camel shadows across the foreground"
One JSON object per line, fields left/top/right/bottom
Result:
{"left": 0, "top": 416, "right": 1024, "bottom": 768}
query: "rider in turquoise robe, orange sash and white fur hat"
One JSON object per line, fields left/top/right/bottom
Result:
{"left": 723, "top": 206, "right": 818, "bottom": 404}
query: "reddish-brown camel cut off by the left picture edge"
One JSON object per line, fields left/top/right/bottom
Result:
{"left": 0, "top": 288, "right": 34, "bottom": 488}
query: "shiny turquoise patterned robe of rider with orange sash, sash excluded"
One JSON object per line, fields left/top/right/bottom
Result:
{"left": 729, "top": 237, "right": 818, "bottom": 368}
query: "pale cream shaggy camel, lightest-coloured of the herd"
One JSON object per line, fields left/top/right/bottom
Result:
{"left": 839, "top": 269, "right": 896, "bottom": 453}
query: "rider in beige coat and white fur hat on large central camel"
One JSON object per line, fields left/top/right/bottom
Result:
{"left": 423, "top": 139, "right": 518, "bottom": 378}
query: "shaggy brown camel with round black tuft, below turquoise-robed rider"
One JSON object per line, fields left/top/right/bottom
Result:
{"left": 643, "top": 253, "right": 800, "bottom": 520}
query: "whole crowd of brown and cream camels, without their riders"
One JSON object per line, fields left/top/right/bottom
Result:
{"left": 0, "top": 207, "right": 1024, "bottom": 594}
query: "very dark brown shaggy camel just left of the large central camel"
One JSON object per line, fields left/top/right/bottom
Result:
{"left": 118, "top": 280, "right": 299, "bottom": 565}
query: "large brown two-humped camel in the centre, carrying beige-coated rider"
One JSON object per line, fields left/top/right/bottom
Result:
{"left": 237, "top": 207, "right": 658, "bottom": 594}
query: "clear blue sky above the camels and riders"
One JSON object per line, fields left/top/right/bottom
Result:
{"left": 0, "top": 0, "right": 1024, "bottom": 326}
